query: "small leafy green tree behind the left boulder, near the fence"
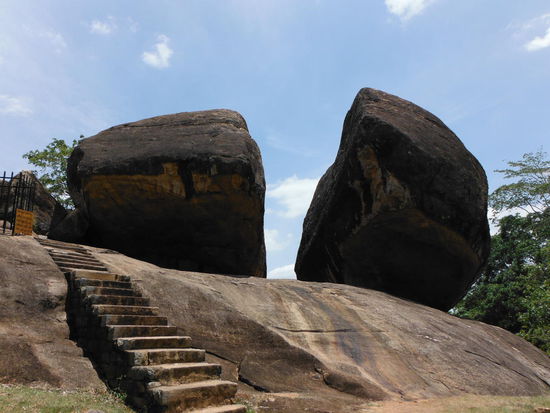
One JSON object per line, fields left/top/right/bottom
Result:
{"left": 23, "top": 135, "right": 83, "bottom": 208}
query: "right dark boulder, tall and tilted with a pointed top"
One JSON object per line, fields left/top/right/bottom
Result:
{"left": 295, "top": 89, "right": 490, "bottom": 310}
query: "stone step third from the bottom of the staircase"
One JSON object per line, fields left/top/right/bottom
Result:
{"left": 128, "top": 362, "right": 222, "bottom": 385}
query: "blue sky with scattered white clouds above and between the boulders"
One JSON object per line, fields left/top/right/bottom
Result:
{"left": 0, "top": 0, "right": 550, "bottom": 278}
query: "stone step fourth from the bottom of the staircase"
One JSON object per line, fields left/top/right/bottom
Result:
{"left": 125, "top": 348, "right": 205, "bottom": 366}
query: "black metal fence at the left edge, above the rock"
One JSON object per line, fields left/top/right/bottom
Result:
{"left": 0, "top": 171, "right": 35, "bottom": 235}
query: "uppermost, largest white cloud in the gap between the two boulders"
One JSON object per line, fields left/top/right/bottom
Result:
{"left": 267, "top": 175, "right": 319, "bottom": 218}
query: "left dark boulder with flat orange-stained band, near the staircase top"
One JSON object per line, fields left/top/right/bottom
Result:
{"left": 56, "top": 110, "right": 266, "bottom": 277}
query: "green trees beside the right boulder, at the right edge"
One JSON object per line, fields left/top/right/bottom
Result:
{"left": 452, "top": 150, "right": 550, "bottom": 354}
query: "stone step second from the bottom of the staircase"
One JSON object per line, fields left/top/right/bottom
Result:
{"left": 149, "top": 380, "right": 237, "bottom": 411}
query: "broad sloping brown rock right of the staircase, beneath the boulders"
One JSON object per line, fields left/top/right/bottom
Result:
{"left": 94, "top": 250, "right": 550, "bottom": 413}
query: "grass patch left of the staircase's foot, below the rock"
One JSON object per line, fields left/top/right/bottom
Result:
{"left": 0, "top": 385, "right": 134, "bottom": 413}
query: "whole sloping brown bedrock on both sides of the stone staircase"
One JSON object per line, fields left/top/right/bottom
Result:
{"left": 0, "top": 236, "right": 550, "bottom": 413}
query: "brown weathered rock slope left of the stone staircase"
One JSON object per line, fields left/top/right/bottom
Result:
{"left": 0, "top": 235, "right": 106, "bottom": 391}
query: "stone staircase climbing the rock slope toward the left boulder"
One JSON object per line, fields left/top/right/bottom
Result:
{"left": 37, "top": 238, "right": 246, "bottom": 413}
